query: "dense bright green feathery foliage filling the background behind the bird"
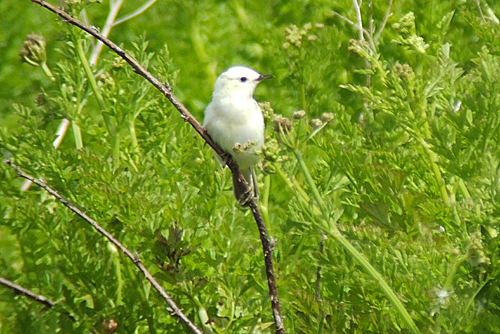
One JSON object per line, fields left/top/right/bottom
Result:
{"left": 0, "top": 0, "right": 500, "bottom": 333}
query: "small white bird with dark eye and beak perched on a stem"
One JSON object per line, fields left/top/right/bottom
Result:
{"left": 203, "top": 66, "right": 272, "bottom": 206}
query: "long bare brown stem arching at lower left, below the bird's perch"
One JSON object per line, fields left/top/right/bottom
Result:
{"left": 5, "top": 160, "right": 203, "bottom": 334}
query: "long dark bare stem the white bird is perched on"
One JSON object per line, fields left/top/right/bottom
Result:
{"left": 27, "top": 0, "right": 286, "bottom": 334}
